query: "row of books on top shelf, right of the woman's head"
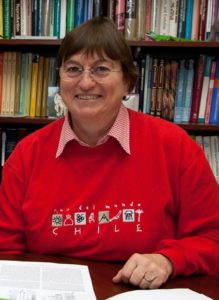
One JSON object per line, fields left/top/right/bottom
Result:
{"left": 107, "top": 0, "right": 219, "bottom": 40}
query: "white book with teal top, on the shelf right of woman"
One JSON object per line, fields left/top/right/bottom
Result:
{"left": 198, "top": 55, "right": 212, "bottom": 123}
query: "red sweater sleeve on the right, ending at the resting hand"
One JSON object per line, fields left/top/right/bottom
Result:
{"left": 156, "top": 141, "right": 219, "bottom": 276}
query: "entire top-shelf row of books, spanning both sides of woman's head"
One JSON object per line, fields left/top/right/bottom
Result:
{"left": 0, "top": 0, "right": 219, "bottom": 40}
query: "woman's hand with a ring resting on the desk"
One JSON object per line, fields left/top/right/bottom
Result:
{"left": 112, "top": 253, "right": 173, "bottom": 289}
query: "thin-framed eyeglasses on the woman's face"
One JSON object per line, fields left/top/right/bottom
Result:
{"left": 60, "top": 66, "right": 121, "bottom": 82}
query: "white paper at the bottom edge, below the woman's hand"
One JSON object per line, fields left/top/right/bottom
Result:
{"left": 106, "top": 288, "right": 213, "bottom": 300}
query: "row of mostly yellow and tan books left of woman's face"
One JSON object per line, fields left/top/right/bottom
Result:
{"left": 0, "top": 51, "right": 57, "bottom": 117}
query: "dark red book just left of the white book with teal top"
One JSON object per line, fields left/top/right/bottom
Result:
{"left": 190, "top": 55, "right": 205, "bottom": 123}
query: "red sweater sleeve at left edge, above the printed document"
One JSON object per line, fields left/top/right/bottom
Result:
{"left": 0, "top": 143, "right": 26, "bottom": 254}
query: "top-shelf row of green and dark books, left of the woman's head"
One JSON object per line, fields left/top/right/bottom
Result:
{"left": 0, "top": 0, "right": 103, "bottom": 39}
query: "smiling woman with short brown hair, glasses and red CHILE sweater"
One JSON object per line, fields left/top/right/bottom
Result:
{"left": 0, "top": 18, "right": 219, "bottom": 288}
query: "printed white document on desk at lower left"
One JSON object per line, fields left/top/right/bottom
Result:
{"left": 0, "top": 260, "right": 96, "bottom": 300}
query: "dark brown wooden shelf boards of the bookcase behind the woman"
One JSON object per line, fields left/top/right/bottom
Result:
{"left": 0, "top": 38, "right": 219, "bottom": 135}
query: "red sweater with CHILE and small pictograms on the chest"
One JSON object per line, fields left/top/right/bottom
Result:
{"left": 0, "top": 111, "right": 219, "bottom": 275}
